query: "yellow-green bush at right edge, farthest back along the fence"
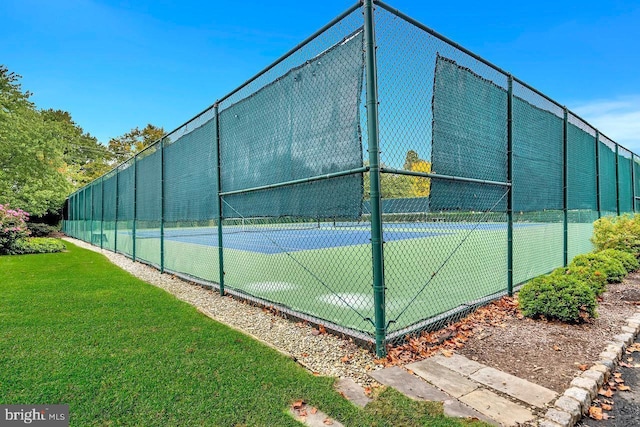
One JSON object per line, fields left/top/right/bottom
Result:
{"left": 591, "top": 214, "right": 640, "bottom": 257}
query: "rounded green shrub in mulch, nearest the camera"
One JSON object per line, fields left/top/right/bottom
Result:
{"left": 518, "top": 274, "right": 597, "bottom": 323}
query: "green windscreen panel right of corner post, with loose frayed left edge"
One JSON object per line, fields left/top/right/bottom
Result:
{"left": 431, "top": 56, "right": 507, "bottom": 211}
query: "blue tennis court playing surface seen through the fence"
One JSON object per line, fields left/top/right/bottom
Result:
{"left": 134, "top": 222, "right": 543, "bottom": 254}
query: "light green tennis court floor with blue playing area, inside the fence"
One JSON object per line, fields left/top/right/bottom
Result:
{"left": 85, "top": 222, "right": 593, "bottom": 334}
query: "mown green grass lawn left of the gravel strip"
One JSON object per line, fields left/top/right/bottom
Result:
{"left": 0, "top": 244, "right": 484, "bottom": 426}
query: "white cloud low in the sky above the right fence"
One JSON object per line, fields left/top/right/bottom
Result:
{"left": 571, "top": 95, "right": 640, "bottom": 154}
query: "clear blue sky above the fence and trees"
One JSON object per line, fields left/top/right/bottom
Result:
{"left": 0, "top": 0, "right": 640, "bottom": 153}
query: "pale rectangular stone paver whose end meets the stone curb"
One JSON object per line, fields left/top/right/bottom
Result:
{"left": 468, "top": 367, "right": 558, "bottom": 408}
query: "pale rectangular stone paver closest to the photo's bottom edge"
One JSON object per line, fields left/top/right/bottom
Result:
{"left": 460, "top": 389, "right": 534, "bottom": 426}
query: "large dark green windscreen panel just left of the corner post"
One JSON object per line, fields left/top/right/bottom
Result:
{"left": 220, "top": 31, "right": 364, "bottom": 218}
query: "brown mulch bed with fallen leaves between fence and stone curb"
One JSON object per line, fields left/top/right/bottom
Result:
{"left": 384, "top": 273, "right": 640, "bottom": 392}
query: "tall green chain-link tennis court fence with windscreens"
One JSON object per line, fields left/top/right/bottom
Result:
{"left": 63, "top": 0, "right": 640, "bottom": 355}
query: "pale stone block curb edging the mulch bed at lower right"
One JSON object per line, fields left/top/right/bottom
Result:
{"left": 538, "top": 311, "right": 640, "bottom": 427}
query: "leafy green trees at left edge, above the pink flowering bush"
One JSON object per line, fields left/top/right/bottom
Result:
{"left": 0, "top": 65, "right": 111, "bottom": 216}
